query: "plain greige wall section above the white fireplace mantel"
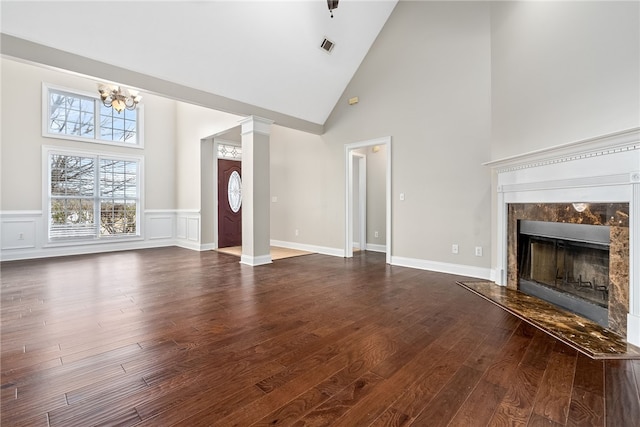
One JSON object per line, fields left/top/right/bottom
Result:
{"left": 491, "top": 1, "right": 640, "bottom": 159}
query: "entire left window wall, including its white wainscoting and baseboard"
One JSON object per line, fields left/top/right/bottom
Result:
{"left": 0, "top": 58, "right": 176, "bottom": 260}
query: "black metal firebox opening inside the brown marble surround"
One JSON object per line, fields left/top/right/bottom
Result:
{"left": 517, "top": 220, "right": 610, "bottom": 327}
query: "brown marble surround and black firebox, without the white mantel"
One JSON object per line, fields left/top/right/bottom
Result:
{"left": 506, "top": 203, "right": 629, "bottom": 336}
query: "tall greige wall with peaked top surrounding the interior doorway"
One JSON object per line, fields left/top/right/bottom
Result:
{"left": 323, "top": 2, "right": 491, "bottom": 274}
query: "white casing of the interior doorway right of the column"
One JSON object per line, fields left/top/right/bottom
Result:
{"left": 344, "top": 136, "right": 392, "bottom": 264}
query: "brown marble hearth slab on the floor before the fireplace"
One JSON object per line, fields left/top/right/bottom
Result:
{"left": 458, "top": 281, "right": 640, "bottom": 359}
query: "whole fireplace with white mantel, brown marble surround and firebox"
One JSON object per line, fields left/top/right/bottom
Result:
{"left": 486, "top": 128, "right": 640, "bottom": 345}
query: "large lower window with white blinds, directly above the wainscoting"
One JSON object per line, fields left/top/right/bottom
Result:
{"left": 47, "top": 150, "right": 141, "bottom": 241}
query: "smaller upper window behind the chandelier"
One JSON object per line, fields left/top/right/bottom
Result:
{"left": 43, "top": 84, "right": 142, "bottom": 147}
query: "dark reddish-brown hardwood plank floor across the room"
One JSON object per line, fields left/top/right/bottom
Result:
{"left": 0, "top": 248, "right": 640, "bottom": 427}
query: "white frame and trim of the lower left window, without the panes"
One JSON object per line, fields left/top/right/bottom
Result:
{"left": 42, "top": 146, "right": 144, "bottom": 247}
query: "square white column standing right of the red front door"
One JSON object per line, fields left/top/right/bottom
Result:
{"left": 240, "top": 116, "right": 273, "bottom": 266}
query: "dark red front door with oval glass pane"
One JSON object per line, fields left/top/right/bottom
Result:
{"left": 218, "top": 159, "right": 242, "bottom": 248}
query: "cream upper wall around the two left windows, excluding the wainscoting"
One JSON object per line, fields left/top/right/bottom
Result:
{"left": 1, "top": 58, "right": 176, "bottom": 210}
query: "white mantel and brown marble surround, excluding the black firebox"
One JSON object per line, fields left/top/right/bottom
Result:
{"left": 486, "top": 128, "right": 640, "bottom": 345}
